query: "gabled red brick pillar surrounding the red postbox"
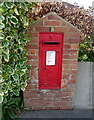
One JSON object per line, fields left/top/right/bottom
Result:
{"left": 24, "top": 12, "right": 80, "bottom": 110}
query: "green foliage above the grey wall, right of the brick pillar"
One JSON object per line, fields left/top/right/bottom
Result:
{"left": 78, "top": 34, "right": 94, "bottom": 62}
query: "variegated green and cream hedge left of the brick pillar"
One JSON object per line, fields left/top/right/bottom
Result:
{"left": 0, "top": 2, "right": 35, "bottom": 120}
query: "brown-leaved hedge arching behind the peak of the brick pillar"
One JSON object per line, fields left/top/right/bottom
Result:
{"left": 28, "top": 2, "right": 94, "bottom": 39}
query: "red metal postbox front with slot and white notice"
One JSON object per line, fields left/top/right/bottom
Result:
{"left": 39, "top": 33, "right": 64, "bottom": 89}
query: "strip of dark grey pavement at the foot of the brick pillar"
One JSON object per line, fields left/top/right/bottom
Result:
{"left": 17, "top": 110, "right": 94, "bottom": 120}
